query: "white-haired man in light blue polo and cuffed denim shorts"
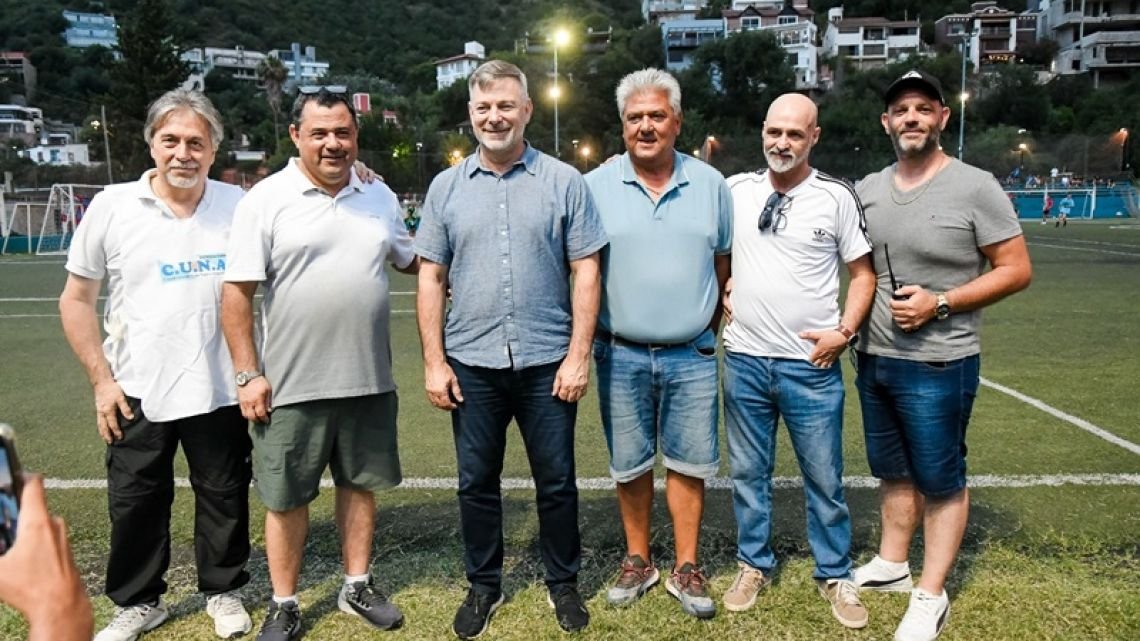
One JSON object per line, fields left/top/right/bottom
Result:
{"left": 586, "top": 68, "right": 732, "bottom": 618}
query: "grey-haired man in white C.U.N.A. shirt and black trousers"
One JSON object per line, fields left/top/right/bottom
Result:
{"left": 59, "top": 90, "right": 252, "bottom": 641}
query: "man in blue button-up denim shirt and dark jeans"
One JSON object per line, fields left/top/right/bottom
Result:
{"left": 416, "top": 60, "right": 606, "bottom": 639}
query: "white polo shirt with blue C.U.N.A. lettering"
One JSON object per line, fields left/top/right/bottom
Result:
{"left": 66, "top": 170, "right": 243, "bottom": 421}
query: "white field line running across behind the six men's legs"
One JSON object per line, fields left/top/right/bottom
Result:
{"left": 44, "top": 474, "right": 1140, "bottom": 490}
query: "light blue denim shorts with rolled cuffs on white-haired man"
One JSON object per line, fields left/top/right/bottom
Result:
{"left": 594, "top": 330, "right": 720, "bottom": 482}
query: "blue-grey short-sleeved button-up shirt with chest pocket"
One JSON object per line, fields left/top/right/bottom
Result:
{"left": 415, "top": 144, "right": 606, "bottom": 370}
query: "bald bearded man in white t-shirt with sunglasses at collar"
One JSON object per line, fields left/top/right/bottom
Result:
{"left": 724, "top": 94, "right": 874, "bottom": 627}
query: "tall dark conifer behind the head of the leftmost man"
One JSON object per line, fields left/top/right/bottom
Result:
{"left": 106, "top": 0, "right": 188, "bottom": 177}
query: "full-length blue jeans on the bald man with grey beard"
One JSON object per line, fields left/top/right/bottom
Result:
{"left": 724, "top": 351, "right": 852, "bottom": 578}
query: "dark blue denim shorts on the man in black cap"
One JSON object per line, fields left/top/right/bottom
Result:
{"left": 855, "top": 351, "right": 982, "bottom": 498}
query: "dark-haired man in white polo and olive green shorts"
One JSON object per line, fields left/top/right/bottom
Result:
{"left": 222, "top": 87, "right": 420, "bottom": 641}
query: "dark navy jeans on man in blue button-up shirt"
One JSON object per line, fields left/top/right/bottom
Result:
{"left": 450, "top": 359, "right": 581, "bottom": 592}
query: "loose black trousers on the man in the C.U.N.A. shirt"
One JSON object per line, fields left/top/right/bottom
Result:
{"left": 106, "top": 398, "right": 251, "bottom": 607}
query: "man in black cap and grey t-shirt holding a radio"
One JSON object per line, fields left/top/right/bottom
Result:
{"left": 854, "top": 71, "right": 1032, "bottom": 641}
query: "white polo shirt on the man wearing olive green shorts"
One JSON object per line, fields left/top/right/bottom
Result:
{"left": 226, "top": 159, "right": 415, "bottom": 406}
